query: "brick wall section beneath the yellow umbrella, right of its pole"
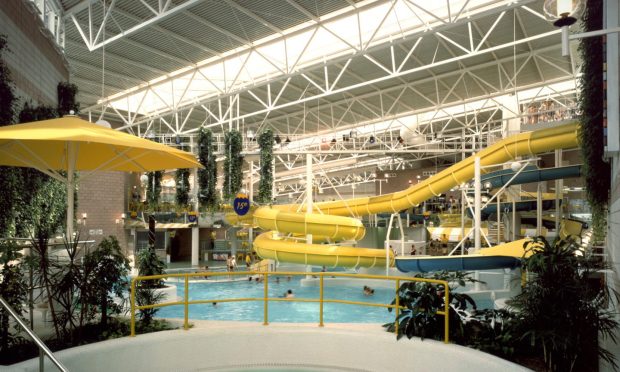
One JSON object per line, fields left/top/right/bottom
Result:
{"left": 76, "top": 172, "right": 133, "bottom": 252}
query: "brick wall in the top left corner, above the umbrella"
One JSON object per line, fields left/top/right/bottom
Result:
{"left": 0, "top": 0, "right": 69, "bottom": 107}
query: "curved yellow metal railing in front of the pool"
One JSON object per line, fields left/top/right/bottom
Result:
{"left": 130, "top": 271, "right": 450, "bottom": 343}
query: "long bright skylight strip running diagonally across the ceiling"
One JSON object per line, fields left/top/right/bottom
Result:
{"left": 99, "top": 0, "right": 511, "bottom": 115}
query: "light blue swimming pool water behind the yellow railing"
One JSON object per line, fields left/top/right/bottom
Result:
{"left": 157, "top": 277, "right": 394, "bottom": 323}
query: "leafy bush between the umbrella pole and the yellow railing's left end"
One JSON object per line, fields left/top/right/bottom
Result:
{"left": 82, "top": 235, "right": 130, "bottom": 327}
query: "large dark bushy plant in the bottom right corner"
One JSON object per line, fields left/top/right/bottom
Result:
{"left": 509, "top": 237, "right": 619, "bottom": 371}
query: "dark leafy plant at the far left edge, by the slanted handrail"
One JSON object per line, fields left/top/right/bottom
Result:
{"left": 0, "top": 240, "right": 27, "bottom": 354}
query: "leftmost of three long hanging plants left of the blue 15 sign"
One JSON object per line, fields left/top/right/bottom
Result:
{"left": 198, "top": 127, "right": 218, "bottom": 210}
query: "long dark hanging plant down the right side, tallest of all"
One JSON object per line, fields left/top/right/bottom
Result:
{"left": 579, "top": 1, "right": 611, "bottom": 237}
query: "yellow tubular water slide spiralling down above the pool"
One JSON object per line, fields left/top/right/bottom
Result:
{"left": 246, "top": 123, "right": 578, "bottom": 267}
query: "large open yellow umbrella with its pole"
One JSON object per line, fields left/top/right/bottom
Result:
{"left": 0, "top": 116, "right": 202, "bottom": 237}
